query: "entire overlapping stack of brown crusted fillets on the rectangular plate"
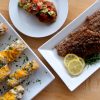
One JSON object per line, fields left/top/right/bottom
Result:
{"left": 56, "top": 10, "right": 100, "bottom": 58}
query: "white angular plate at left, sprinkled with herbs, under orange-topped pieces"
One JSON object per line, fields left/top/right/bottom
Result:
{"left": 0, "top": 14, "right": 54, "bottom": 100}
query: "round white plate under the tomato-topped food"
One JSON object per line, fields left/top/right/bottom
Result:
{"left": 9, "top": 0, "right": 68, "bottom": 38}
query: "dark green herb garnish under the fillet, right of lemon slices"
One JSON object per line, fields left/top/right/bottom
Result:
{"left": 85, "top": 53, "right": 100, "bottom": 65}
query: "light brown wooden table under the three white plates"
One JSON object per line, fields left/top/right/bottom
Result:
{"left": 0, "top": 0, "right": 100, "bottom": 100}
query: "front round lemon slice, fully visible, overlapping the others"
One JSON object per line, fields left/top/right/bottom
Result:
{"left": 67, "top": 59, "right": 84, "bottom": 76}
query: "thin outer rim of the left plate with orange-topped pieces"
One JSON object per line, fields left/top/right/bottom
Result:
{"left": 0, "top": 13, "right": 55, "bottom": 99}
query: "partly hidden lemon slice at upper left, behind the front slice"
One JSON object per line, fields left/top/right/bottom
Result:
{"left": 64, "top": 54, "right": 79, "bottom": 67}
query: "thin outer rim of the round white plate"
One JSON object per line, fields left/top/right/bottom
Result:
{"left": 8, "top": 0, "right": 69, "bottom": 38}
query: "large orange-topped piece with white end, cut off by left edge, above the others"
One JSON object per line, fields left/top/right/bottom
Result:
{"left": 0, "top": 40, "right": 26, "bottom": 63}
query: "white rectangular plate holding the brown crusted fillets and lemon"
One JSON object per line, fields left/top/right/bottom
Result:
{"left": 38, "top": 2, "right": 100, "bottom": 91}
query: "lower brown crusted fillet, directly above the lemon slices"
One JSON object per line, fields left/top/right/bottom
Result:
{"left": 56, "top": 29, "right": 100, "bottom": 58}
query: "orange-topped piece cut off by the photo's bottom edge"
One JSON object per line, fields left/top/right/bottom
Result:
{"left": 0, "top": 85, "right": 24, "bottom": 100}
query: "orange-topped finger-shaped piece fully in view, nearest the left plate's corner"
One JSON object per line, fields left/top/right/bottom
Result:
{"left": 7, "top": 60, "right": 39, "bottom": 87}
